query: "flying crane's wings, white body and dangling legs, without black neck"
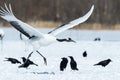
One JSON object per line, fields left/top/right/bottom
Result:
{"left": 0, "top": 4, "right": 94, "bottom": 65}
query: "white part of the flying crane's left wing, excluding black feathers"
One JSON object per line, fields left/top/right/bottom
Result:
{"left": 0, "top": 4, "right": 43, "bottom": 38}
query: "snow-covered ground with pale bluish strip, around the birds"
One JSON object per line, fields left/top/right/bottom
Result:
{"left": 0, "top": 28, "right": 120, "bottom": 80}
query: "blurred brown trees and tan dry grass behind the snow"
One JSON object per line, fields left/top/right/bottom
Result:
{"left": 0, "top": 0, "right": 120, "bottom": 29}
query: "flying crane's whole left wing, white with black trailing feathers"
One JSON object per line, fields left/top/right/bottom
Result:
{"left": 0, "top": 4, "right": 43, "bottom": 38}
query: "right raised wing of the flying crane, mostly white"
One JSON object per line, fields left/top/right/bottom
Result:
{"left": 48, "top": 5, "right": 94, "bottom": 36}
